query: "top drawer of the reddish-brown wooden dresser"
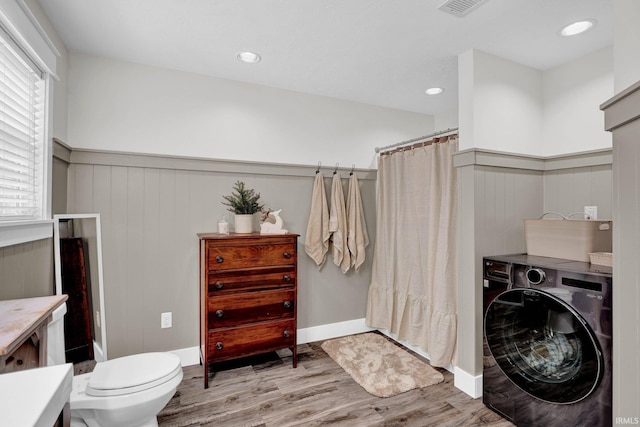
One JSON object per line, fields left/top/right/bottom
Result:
{"left": 207, "top": 239, "right": 297, "bottom": 271}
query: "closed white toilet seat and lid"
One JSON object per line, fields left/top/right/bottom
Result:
{"left": 85, "top": 353, "right": 182, "bottom": 397}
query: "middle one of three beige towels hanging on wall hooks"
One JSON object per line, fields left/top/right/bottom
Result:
{"left": 329, "top": 173, "right": 351, "bottom": 273}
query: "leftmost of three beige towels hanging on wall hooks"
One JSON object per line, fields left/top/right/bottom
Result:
{"left": 304, "top": 172, "right": 331, "bottom": 267}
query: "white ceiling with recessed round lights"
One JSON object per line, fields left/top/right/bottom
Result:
{"left": 38, "top": 0, "right": 613, "bottom": 114}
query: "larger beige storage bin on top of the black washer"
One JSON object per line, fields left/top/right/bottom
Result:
{"left": 524, "top": 219, "right": 612, "bottom": 262}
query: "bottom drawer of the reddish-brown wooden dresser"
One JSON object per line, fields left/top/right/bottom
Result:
{"left": 208, "top": 319, "right": 296, "bottom": 362}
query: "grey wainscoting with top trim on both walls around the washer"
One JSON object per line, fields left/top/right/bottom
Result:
{"left": 454, "top": 150, "right": 615, "bottom": 378}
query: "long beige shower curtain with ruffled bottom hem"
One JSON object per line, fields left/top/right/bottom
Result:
{"left": 366, "top": 135, "right": 458, "bottom": 367}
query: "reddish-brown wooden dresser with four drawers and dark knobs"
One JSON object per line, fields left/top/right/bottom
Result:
{"left": 198, "top": 233, "right": 298, "bottom": 388}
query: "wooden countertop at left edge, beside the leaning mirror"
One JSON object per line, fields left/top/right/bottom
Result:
{"left": 0, "top": 295, "right": 68, "bottom": 356}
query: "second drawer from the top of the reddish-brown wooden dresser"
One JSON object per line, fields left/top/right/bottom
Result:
{"left": 207, "top": 265, "right": 296, "bottom": 297}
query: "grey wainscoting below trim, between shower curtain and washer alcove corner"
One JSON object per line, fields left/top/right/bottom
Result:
{"left": 457, "top": 164, "right": 543, "bottom": 382}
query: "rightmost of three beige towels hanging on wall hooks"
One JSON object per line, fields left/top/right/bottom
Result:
{"left": 347, "top": 175, "right": 369, "bottom": 271}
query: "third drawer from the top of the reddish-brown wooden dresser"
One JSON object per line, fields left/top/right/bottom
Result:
{"left": 208, "top": 289, "right": 296, "bottom": 329}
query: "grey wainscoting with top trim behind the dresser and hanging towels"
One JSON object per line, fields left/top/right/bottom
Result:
{"left": 68, "top": 151, "right": 376, "bottom": 358}
